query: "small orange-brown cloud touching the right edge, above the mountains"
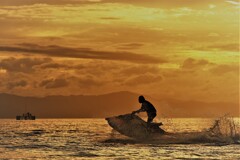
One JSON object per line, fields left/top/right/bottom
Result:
{"left": 210, "top": 64, "right": 239, "bottom": 75}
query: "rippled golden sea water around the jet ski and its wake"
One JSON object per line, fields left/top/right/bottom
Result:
{"left": 0, "top": 118, "right": 240, "bottom": 160}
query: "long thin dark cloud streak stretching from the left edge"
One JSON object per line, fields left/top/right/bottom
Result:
{"left": 0, "top": 44, "right": 166, "bottom": 63}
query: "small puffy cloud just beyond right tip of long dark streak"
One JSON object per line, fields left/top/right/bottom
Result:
{"left": 182, "top": 58, "right": 211, "bottom": 69}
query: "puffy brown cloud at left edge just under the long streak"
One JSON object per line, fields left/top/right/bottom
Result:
{"left": 0, "top": 57, "right": 52, "bottom": 73}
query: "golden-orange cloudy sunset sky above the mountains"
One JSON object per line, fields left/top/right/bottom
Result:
{"left": 0, "top": 0, "right": 240, "bottom": 103}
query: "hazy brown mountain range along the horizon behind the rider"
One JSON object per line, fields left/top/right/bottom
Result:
{"left": 0, "top": 91, "right": 239, "bottom": 118}
